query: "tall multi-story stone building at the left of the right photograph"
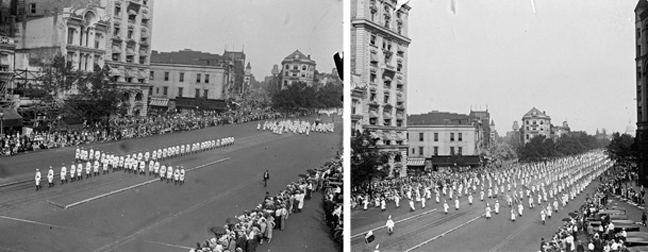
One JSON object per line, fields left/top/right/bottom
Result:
{"left": 350, "top": 0, "right": 411, "bottom": 176}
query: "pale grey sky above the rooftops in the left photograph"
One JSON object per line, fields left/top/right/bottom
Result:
{"left": 151, "top": 0, "right": 343, "bottom": 80}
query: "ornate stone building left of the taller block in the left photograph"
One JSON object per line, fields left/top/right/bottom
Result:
{"left": 15, "top": 5, "right": 110, "bottom": 94}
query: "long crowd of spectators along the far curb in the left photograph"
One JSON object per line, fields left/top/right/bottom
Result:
{"left": 0, "top": 111, "right": 286, "bottom": 155}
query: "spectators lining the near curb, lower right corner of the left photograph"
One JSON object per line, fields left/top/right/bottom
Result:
{"left": 190, "top": 151, "right": 343, "bottom": 252}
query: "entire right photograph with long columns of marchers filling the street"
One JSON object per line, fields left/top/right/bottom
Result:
{"left": 347, "top": 0, "right": 648, "bottom": 252}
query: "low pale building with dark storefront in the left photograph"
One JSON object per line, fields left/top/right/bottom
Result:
{"left": 149, "top": 50, "right": 228, "bottom": 112}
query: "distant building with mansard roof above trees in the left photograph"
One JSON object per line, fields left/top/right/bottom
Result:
{"left": 280, "top": 50, "right": 317, "bottom": 89}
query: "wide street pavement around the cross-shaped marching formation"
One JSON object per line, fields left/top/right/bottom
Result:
{"left": 0, "top": 114, "right": 342, "bottom": 251}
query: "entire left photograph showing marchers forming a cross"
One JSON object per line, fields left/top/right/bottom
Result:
{"left": 0, "top": 0, "right": 348, "bottom": 252}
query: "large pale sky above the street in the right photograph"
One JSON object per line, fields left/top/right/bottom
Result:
{"left": 407, "top": 0, "right": 637, "bottom": 135}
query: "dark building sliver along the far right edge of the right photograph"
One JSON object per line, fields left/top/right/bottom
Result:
{"left": 634, "top": 0, "right": 648, "bottom": 186}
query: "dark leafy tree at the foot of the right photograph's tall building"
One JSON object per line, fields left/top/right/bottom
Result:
{"left": 351, "top": 130, "right": 389, "bottom": 187}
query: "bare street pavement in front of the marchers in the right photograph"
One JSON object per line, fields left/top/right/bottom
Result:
{"left": 351, "top": 163, "right": 624, "bottom": 252}
